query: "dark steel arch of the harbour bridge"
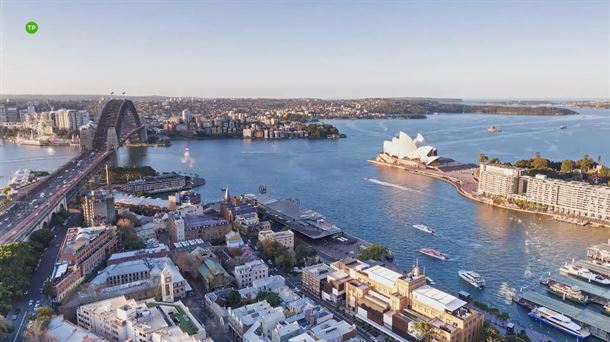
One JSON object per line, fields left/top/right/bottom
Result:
{"left": 93, "top": 99, "right": 146, "bottom": 150}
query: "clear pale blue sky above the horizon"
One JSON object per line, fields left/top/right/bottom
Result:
{"left": 0, "top": 0, "right": 610, "bottom": 98}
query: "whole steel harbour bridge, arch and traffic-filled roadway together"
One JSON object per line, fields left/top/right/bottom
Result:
{"left": 0, "top": 99, "right": 147, "bottom": 243}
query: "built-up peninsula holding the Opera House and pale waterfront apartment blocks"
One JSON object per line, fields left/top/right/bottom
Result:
{"left": 368, "top": 132, "right": 610, "bottom": 227}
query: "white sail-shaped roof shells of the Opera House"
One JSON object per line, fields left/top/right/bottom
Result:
{"left": 383, "top": 132, "right": 439, "bottom": 165}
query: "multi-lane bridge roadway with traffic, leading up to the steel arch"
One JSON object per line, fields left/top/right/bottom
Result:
{"left": 0, "top": 150, "right": 114, "bottom": 243}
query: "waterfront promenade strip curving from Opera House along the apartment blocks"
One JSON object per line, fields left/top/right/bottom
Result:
{"left": 367, "top": 159, "right": 610, "bottom": 228}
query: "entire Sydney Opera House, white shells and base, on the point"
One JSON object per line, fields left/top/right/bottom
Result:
{"left": 377, "top": 132, "right": 440, "bottom": 167}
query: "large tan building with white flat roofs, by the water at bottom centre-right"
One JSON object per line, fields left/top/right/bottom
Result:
{"left": 334, "top": 260, "right": 484, "bottom": 342}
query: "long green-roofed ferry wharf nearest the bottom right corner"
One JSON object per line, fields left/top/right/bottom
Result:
{"left": 515, "top": 291, "right": 610, "bottom": 341}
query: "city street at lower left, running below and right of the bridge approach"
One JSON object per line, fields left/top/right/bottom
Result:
{"left": 7, "top": 214, "right": 78, "bottom": 342}
